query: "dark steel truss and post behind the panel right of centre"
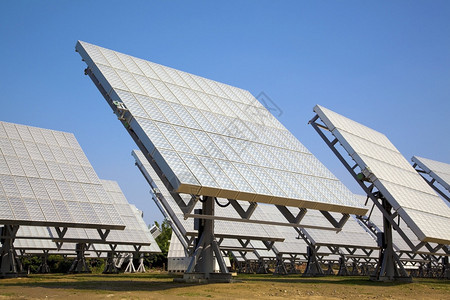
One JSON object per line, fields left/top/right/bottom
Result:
{"left": 309, "top": 115, "right": 449, "bottom": 281}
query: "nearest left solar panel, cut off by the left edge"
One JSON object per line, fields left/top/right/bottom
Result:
{"left": 0, "top": 122, "right": 124, "bottom": 229}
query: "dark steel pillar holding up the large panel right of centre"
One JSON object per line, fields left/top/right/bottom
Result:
{"left": 370, "top": 198, "right": 412, "bottom": 282}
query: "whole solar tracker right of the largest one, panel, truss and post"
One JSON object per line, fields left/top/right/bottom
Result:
{"left": 310, "top": 105, "right": 450, "bottom": 280}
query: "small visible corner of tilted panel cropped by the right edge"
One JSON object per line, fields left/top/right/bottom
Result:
{"left": 411, "top": 156, "right": 450, "bottom": 202}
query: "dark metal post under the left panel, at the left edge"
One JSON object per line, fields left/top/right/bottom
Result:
{"left": 0, "top": 224, "right": 21, "bottom": 277}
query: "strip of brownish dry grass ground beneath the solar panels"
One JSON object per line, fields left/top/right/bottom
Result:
{"left": 0, "top": 273, "right": 450, "bottom": 300}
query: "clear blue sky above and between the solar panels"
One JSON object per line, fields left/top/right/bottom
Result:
{"left": 0, "top": 0, "right": 450, "bottom": 223}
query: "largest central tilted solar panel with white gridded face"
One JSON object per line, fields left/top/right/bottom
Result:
{"left": 76, "top": 41, "right": 364, "bottom": 214}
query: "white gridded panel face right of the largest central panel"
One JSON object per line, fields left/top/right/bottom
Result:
{"left": 314, "top": 105, "right": 450, "bottom": 244}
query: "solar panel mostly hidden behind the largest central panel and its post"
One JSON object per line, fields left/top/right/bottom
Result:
{"left": 132, "top": 150, "right": 283, "bottom": 240}
